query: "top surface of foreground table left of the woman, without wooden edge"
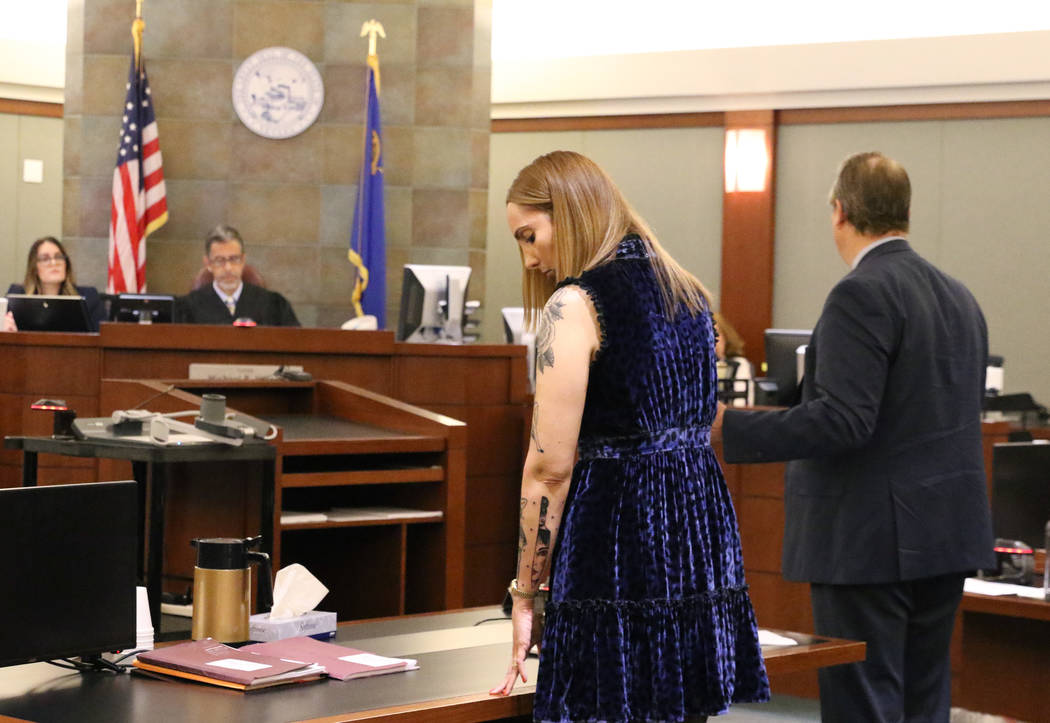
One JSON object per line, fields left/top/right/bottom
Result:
{"left": 0, "top": 607, "right": 525, "bottom": 723}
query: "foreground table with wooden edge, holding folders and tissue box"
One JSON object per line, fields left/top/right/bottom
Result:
{"left": 0, "top": 607, "right": 864, "bottom": 723}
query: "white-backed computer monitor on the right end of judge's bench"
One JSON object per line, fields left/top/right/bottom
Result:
{"left": 397, "top": 263, "right": 470, "bottom": 343}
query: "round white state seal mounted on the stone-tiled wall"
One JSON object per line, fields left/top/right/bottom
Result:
{"left": 233, "top": 47, "right": 324, "bottom": 139}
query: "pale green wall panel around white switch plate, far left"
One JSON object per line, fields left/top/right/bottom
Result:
{"left": 0, "top": 113, "right": 62, "bottom": 281}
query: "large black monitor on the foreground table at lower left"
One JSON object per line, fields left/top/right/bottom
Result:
{"left": 0, "top": 482, "right": 139, "bottom": 665}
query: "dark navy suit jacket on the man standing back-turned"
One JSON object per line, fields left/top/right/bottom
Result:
{"left": 722, "top": 239, "right": 994, "bottom": 584}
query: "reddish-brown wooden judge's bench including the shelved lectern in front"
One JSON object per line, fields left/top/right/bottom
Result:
{"left": 0, "top": 323, "right": 528, "bottom": 619}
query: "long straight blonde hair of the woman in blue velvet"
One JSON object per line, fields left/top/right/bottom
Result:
{"left": 506, "top": 151, "right": 711, "bottom": 325}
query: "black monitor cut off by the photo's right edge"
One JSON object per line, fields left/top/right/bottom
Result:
{"left": 991, "top": 441, "right": 1050, "bottom": 548}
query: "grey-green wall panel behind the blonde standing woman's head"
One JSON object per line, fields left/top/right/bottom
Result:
{"left": 480, "top": 128, "right": 722, "bottom": 342}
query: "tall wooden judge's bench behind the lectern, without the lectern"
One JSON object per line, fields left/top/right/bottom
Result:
{"left": 0, "top": 323, "right": 528, "bottom": 604}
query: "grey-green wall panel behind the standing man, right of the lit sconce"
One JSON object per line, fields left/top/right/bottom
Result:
{"left": 773, "top": 118, "right": 1050, "bottom": 404}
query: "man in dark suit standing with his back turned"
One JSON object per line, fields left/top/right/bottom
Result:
{"left": 716, "top": 153, "right": 994, "bottom": 723}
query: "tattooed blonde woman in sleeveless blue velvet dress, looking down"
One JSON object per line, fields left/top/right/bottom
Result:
{"left": 491, "top": 151, "right": 770, "bottom": 722}
